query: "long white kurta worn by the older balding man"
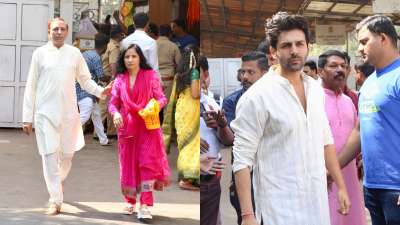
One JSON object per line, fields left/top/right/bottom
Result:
{"left": 22, "top": 42, "right": 103, "bottom": 155}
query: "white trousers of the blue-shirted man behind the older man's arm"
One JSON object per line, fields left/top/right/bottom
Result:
{"left": 78, "top": 97, "right": 108, "bottom": 144}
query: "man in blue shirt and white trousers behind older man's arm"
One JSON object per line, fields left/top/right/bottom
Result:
{"left": 75, "top": 33, "right": 109, "bottom": 145}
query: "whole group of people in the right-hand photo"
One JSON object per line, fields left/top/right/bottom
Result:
{"left": 199, "top": 12, "right": 400, "bottom": 225}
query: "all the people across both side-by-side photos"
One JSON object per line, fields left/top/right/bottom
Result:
{"left": 18, "top": 5, "right": 400, "bottom": 225}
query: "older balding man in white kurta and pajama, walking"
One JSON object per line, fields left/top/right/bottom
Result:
{"left": 23, "top": 19, "right": 109, "bottom": 215}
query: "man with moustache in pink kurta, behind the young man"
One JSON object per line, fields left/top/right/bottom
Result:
{"left": 318, "top": 50, "right": 366, "bottom": 225}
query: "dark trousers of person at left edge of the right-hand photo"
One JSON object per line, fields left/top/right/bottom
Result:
{"left": 200, "top": 176, "right": 221, "bottom": 225}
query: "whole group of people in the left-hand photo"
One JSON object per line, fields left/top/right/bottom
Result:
{"left": 23, "top": 9, "right": 200, "bottom": 222}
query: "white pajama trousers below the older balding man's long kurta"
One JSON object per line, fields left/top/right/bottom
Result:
{"left": 42, "top": 151, "right": 74, "bottom": 205}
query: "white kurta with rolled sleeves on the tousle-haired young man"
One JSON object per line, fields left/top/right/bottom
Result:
{"left": 231, "top": 70, "right": 333, "bottom": 225}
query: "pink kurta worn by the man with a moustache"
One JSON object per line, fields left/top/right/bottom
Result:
{"left": 325, "top": 89, "right": 366, "bottom": 225}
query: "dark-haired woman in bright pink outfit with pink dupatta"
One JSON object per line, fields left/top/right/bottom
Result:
{"left": 108, "top": 44, "right": 170, "bottom": 220}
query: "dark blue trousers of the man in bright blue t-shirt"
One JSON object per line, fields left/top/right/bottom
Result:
{"left": 364, "top": 187, "right": 400, "bottom": 225}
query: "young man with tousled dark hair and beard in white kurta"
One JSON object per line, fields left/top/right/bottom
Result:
{"left": 231, "top": 13, "right": 349, "bottom": 225}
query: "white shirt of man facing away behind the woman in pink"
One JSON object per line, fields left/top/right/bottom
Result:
{"left": 121, "top": 30, "right": 158, "bottom": 72}
